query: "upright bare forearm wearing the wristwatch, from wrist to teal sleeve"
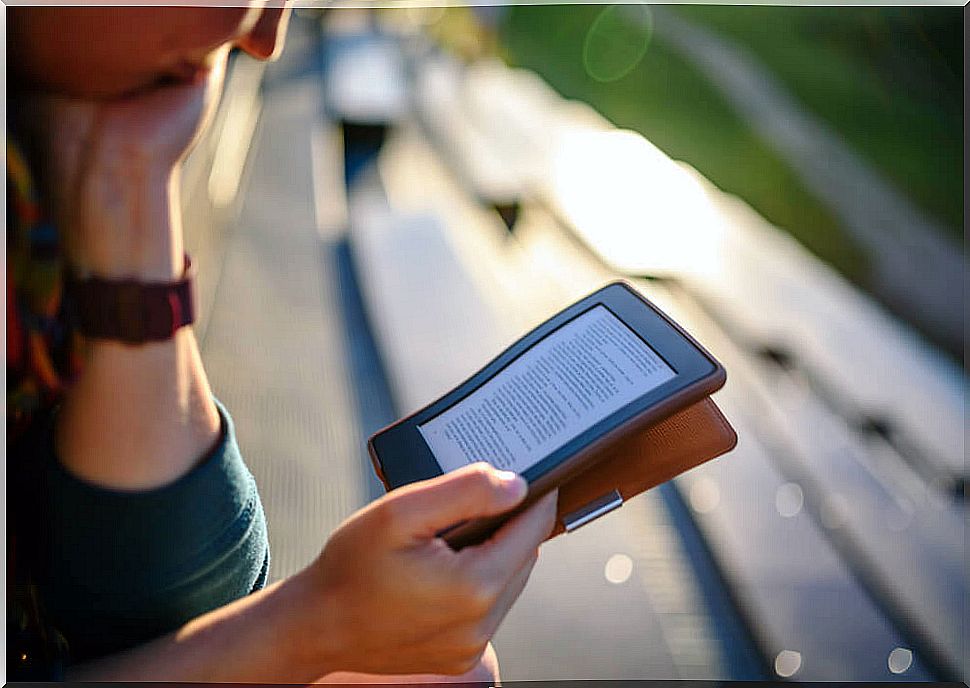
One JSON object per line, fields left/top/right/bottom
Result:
{"left": 57, "top": 170, "right": 219, "bottom": 489}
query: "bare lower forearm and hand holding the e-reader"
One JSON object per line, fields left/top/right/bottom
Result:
{"left": 69, "top": 464, "right": 556, "bottom": 683}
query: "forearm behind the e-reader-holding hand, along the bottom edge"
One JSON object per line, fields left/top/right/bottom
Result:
{"left": 68, "top": 575, "right": 328, "bottom": 683}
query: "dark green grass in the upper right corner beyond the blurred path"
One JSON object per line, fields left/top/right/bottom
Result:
{"left": 675, "top": 5, "right": 963, "bottom": 241}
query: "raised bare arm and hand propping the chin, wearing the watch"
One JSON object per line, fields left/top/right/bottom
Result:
{"left": 35, "top": 55, "right": 225, "bottom": 489}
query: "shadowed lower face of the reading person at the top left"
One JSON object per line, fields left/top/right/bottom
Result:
{"left": 7, "top": 2, "right": 288, "bottom": 98}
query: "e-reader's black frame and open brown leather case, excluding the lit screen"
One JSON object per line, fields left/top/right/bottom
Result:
{"left": 368, "top": 281, "right": 737, "bottom": 548}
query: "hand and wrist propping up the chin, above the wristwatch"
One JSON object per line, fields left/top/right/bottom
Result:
{"left": 25, "top": 46, "right": 228, "bottom": 281}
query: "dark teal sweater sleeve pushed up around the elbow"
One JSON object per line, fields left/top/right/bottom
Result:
{"left": 24, "top": 402, "right": 269, "bottom": 662}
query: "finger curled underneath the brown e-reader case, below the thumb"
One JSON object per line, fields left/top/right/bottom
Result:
{"left": 466, "top": 490, "right": 559, "bottom": 579}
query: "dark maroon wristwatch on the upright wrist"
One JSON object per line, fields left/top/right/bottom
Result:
{"left": 65, "top": 255, "right": 196, "bottom": 344}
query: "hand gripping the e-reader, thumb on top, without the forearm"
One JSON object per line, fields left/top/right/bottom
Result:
{"left": 294, "top": 463, "right": 556, "bottom": 674}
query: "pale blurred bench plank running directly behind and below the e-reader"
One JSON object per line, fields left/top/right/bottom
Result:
{"left": 349, "top": 127, "right": 740, "bottom": 680}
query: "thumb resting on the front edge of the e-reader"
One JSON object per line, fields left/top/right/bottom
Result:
{"left": 384, "top": 463, "right": 528, "bottom": 541}
